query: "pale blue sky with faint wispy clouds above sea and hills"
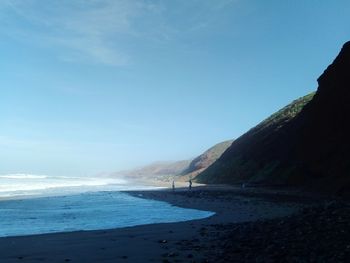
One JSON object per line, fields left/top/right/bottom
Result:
{"left": 0, "top": 0, "right": 350, "bottom": 175}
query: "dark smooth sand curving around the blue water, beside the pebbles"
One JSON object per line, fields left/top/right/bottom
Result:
{"left": 0, "top": 186, "right": 310, "bottom": 263}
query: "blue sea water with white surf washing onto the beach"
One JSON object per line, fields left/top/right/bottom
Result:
{"left": 0, "top": 175, "right": 214, "bottom": 237}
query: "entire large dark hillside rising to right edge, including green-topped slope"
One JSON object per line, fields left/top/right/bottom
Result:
{"left": 196, "top": 42, "right": 350, "bottom": 193}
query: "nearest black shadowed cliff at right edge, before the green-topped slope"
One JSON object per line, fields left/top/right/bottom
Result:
{"left": 292, "top": 42, "right": 350, "bottom": 194}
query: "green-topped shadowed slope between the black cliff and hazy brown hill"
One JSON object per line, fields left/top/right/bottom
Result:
{"left": 196, "top": 92, "right": 315, "bottom": 186}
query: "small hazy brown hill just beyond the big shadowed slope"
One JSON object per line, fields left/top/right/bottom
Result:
{"left": 181, "top": 140, "right": 233, "bottom": 177}
